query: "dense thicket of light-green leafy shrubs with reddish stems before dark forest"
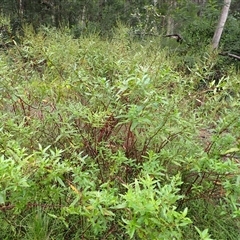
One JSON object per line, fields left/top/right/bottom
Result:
{"left": 0, "top": 23, "right": 240, "bottom": 239}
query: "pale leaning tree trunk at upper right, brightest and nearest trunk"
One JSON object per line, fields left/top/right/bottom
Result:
{"left": 212, "top": 0, "right": 231, "bottom": 49}
